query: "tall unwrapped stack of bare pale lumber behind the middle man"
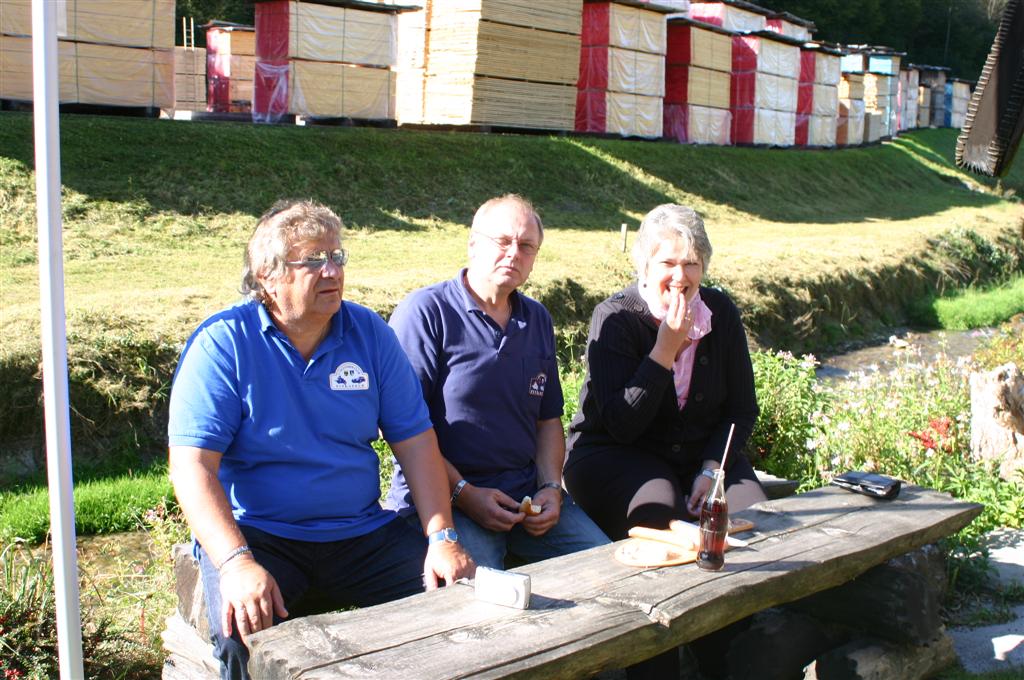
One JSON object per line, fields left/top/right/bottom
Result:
{"left": 398, "top": 0, "right": 583, "bottom": 130}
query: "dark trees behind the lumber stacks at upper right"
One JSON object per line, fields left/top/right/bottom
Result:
{"left": 737, "top": 0, "right": 1007, "bottom": 80}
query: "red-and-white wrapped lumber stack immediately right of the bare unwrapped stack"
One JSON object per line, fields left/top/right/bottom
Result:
{"left": 575, "top": 2, "right": 666, "bottom": 137}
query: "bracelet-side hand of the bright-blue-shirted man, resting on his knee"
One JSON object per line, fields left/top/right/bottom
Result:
{"left": 220, "top": 555, "right": 288, "bottom": 640}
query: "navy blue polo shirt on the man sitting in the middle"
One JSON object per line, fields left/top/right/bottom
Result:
{"left": 385, "top": 269, "right": 563, "bottom": 513}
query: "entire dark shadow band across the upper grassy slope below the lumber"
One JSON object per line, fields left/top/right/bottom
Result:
{"left": 0, "top": 112, "right": 1024, "bottom": 230}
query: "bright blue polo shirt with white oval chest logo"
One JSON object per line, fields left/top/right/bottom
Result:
{"left": 168, "top": 302, "right": 430, "bottom": 542}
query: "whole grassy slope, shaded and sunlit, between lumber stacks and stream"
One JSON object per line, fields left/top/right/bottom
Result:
{"left": 0, "top": 113, "right": 1024, "bottom": 487}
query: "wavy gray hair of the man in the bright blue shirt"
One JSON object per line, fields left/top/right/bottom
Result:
{"left": 240, "top": 200, "right": 342, "bottom": 302}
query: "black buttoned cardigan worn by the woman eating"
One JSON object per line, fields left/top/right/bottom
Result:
{"left": 566, "top": 284, "right": 758, "bottom": 468}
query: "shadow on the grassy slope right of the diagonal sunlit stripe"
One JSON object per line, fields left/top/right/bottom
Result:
{"left": 581, "top": 130, "right": 1001, "bottom": 223}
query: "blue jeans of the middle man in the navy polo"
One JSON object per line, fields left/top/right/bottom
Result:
{"left": 448, "top": 497, "right": 608, "bottom": 569}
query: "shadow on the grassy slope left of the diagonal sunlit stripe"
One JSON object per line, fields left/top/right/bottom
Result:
{"left": 0, "top": 113, "right": 668, "bottom": 230}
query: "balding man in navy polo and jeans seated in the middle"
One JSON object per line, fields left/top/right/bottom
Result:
{"left": 385, "top": 195, "right": 608, "bottom": 568}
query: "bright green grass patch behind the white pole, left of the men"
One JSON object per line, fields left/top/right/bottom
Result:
{"left": 0, "top": 469, "right": 173, "bottom": 543}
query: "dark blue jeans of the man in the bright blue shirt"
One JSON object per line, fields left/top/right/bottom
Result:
{"left": 198, "top": 518, "right": 427, "bottom": 680}
